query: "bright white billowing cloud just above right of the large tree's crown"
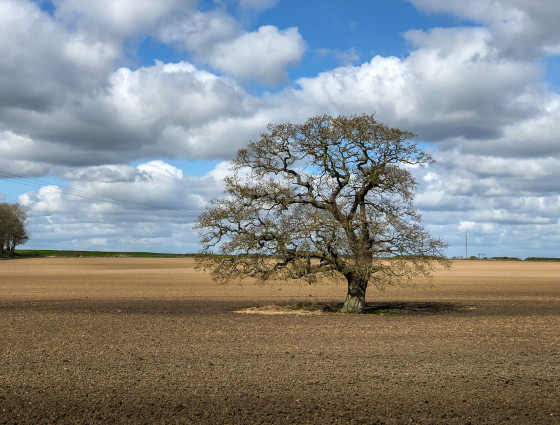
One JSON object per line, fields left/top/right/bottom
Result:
{"left": 295, "top": 28, "right": 542, "bottom": 142}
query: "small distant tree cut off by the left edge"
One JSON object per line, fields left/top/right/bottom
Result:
{"left": 0, "top": 202, "right": 29, "bottom": 255}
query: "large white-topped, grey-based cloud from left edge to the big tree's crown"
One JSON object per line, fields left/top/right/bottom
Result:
{"left": 0, "top": 62, "right": 260, "bottom": 166}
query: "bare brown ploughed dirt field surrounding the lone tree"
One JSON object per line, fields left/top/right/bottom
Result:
{"left": 0, "top": 258, "right": 560, "bottom": 424}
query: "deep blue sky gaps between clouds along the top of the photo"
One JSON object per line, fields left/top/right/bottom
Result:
{"left": 130, "top": 0, "right": 458, "bottom": 91}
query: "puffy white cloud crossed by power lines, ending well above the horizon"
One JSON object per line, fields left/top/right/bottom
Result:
{"left": 20, "top": 160, "right": 228, "bottom": 217}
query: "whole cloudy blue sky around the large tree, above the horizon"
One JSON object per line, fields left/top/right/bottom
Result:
{"left": 0, "top": 0, "right": 560, "bottom": 258}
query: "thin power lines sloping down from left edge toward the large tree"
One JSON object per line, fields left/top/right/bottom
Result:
{"left": 0, "top": 170, "right": 198, "bottom": 214}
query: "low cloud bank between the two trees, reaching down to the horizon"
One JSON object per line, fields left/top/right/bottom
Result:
{"left": 19, "top": 160, "right": 228, "bottom": 252}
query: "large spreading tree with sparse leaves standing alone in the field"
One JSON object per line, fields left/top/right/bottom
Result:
{"left": 195, "top": 115, "right": 448, "bottom": 313}
